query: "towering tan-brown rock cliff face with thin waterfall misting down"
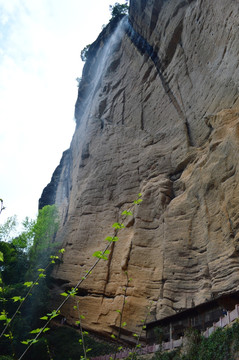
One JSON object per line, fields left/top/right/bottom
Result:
{"left": 40, "top": 0, "right": 239, "bottom": 338}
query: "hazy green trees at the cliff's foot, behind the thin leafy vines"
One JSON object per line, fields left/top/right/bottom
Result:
{"left": 0, "top": 206, "right": 60, "bottom": 360}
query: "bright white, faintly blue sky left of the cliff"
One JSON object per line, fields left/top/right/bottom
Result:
{"left": 0, "top": 0, "right": 125, "bottom": 223}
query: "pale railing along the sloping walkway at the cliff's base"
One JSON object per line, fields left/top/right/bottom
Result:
{"left": 91, "top": 305, "right": 239, "bottom": 360}
